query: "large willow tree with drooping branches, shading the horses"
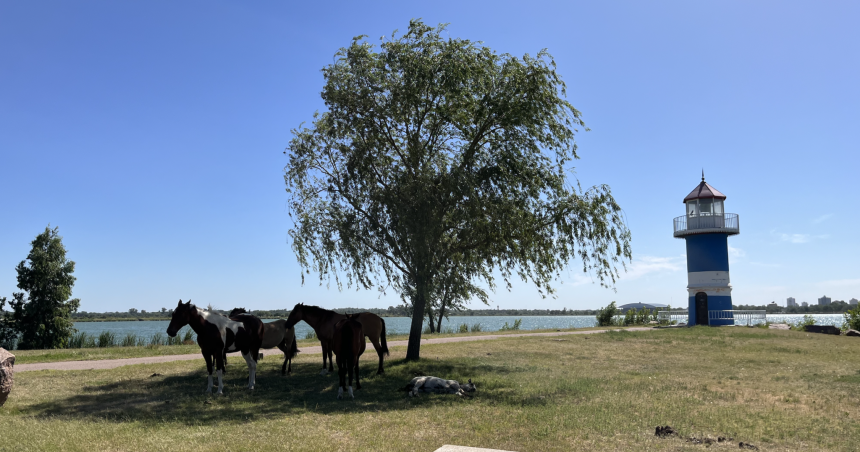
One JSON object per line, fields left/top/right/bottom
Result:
{"left": 284, "top": 21, "right": 630, "bottom": 359}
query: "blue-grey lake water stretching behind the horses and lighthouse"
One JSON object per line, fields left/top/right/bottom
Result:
{"left": 75, "top": 314, "right": 844, "bottom": 339}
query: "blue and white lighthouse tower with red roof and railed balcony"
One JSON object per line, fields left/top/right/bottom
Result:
{"left": 675, "top": 171, "right": 740, "bottom": 325}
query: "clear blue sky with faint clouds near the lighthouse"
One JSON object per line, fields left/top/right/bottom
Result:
{"left": 0, "top": 1, "right": 860, "bottom": 312}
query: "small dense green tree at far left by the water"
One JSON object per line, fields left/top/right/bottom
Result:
{"left": 11, "top": 227, "right": 81, "bottom": 349}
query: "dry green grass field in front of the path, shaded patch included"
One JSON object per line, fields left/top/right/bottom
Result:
{"left": 0, "top": 327, "right": 860, "bottom": 452}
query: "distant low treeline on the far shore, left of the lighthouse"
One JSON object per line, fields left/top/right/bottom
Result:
{"left": 72, "top": 306, "right": 596, "bottom": 322}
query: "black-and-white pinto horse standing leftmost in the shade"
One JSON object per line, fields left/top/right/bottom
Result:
{"left": 167, "top": 300, "right": 263, "bottom": 394}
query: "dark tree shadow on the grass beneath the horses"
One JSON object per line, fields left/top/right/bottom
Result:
{"left": 21, "top": 356, "right": 510, "bottom": 425}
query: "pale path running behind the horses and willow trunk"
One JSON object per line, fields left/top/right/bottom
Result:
{"left": 14, "top": 328, "right": 653, "bottom": 373}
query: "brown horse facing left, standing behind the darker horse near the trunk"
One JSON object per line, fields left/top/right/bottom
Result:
{"left": 286, "top": 303, "right": 389, "bottom": 375}
